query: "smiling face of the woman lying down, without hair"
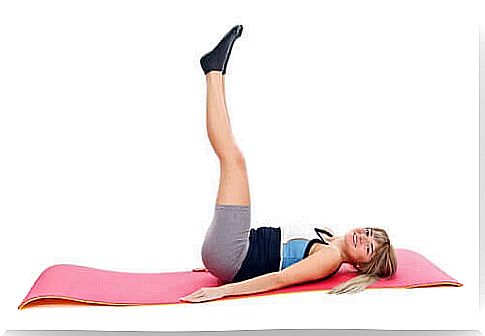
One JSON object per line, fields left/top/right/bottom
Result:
{"left": 345, "top": 228, "right": 378, "bottom": 263}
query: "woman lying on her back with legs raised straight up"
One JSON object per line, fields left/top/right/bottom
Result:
{"left": 181, "top": 25, "right": 396, "bottom": 302}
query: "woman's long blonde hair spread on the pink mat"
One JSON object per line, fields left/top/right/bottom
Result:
{"left": 328, "top": 228, "right": 397, "bottom": 294}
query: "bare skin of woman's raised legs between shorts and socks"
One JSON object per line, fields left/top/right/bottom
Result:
{"left": 206, "top": 71, "right": 250, "bottom": 206}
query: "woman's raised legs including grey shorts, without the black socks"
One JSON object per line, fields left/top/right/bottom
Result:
{"left": 202, "top": 71, "right": 251, "bottom": 282}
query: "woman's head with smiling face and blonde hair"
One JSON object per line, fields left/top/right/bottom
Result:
{"left": 329, "top": 228, "right": 397, "bottom": 294}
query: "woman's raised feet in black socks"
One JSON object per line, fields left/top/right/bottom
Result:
{"left": 200, "top": 25, "right": 243, "bottom": 75}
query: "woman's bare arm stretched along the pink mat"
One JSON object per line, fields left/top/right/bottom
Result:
{"left": 181, "top": 246, "right": 340, "bottom": 302}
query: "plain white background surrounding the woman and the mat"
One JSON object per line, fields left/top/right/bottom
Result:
{"left": 0, "top": 1, "right": 479, "bottom": 330}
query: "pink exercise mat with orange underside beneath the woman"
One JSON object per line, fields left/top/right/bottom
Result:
{"left": 19, "top": 249, "right": 462, "bottom": 309}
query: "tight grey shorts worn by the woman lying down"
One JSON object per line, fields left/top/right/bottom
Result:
{"left": 202, "top": 204, "right": 251, "bottom": 283}
